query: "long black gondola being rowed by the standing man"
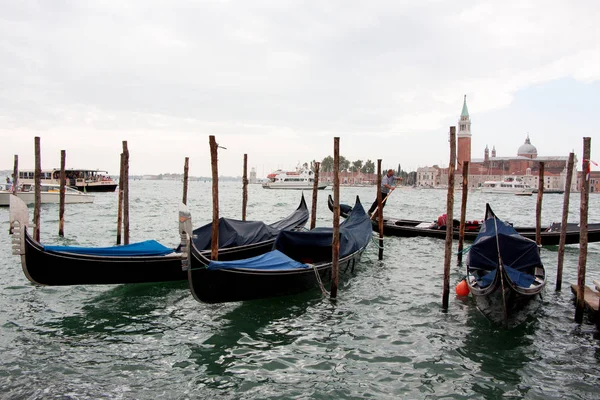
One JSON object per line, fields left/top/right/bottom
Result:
{"left": 328, "top": 196, "right": 600, "bottom": 246}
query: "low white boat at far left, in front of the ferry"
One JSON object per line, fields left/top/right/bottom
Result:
{"left": 0, "top": 183, "right": 94, "bottom": 206}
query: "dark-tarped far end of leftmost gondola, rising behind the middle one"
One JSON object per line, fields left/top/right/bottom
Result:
{"left": 193, "top": 195, "right": 308, "bottom": 250}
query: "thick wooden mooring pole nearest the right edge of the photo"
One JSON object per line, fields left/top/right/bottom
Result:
{"left": 575, "top": 137, "right": 600, "bottom": 323}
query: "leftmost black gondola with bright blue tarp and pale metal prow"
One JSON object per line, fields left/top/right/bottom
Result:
{"left": 10, "top": 195, "right": 308, "bottom": 285}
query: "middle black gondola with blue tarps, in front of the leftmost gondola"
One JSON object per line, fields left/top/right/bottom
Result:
{"left": 188, "top": 197, "right": 373, "bottom": 303}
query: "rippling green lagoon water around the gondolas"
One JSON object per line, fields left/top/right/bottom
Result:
{"left": 0, "top": 181, "right": 600, "bottom": 399}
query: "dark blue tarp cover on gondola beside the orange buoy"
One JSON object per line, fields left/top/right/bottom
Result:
{"left": 469, "top": 206, "right": 542, "bottom": 287}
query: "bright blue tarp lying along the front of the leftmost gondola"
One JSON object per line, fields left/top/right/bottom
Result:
{"left": 44, "top": 240, "right": 174, "bottom": 257}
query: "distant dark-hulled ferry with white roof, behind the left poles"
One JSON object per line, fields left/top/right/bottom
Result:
{"left": 19, "top": 169, "right": 117, "bottom": 192}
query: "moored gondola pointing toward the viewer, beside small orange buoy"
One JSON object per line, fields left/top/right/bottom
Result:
{"left": 466, "top": 204, "right": 546, "bottom": 327}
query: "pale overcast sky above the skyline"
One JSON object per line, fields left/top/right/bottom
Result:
{"left": 0, "top": 0, "right": 600, "bottom": 177}
